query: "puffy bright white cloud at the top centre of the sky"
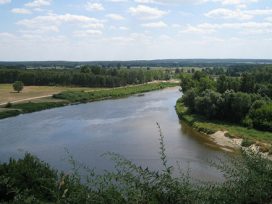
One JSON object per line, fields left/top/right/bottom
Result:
{"left": 129, "top": 5, "right": 167, "bottom": 19}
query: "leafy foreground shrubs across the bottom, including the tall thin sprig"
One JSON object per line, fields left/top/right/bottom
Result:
{"left": 0, "top": 126, "right": 272, "bottom": 204}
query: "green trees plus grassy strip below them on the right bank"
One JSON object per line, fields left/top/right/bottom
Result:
{"left": 177, "top": 66, "right": 272, "bottom": 143}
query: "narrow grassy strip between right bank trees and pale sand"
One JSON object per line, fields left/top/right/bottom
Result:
{"left": 176, "top": 100, "right": 272, "bottom": 144}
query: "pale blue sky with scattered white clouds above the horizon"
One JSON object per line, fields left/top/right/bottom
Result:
{"left": 0, "top": 0, "right": 272, "bottom": 61}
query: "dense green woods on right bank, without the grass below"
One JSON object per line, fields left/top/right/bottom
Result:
{"left": 181, "top": 65, "right": 272, "bottom": 131}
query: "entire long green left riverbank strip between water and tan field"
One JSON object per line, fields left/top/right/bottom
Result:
{"left": 0, "top": 82, "right": 178, "bottom": 119}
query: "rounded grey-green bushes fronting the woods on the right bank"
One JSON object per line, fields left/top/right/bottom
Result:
{"left": 182, "top": 89, "right": 258, "bottom": 123}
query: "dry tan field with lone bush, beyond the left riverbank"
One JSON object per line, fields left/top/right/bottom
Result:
{"left": 0, "top": 84, "right": 101, "bottom": 104}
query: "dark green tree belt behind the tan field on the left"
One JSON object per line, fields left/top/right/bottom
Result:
{"left": 0, "top": 66, "right": 170, "bottom": 87}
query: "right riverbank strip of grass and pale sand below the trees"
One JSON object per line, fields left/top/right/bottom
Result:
{"left": 176, "top": 99, "right": 272, "bottom": 157}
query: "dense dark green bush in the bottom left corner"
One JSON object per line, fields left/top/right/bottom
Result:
{"left": 0, "top": 154, "right": 57, "bottom": 203}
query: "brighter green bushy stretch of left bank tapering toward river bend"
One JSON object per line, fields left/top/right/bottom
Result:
{"left": 53, "top": 82, "right": 178, "bottom": 103}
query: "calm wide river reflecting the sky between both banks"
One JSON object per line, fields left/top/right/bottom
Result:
{"left": 0, "top": 88, "right": 227, "bottom": 180}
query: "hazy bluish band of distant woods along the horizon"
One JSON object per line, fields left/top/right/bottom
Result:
{"left": 0, "top": 59, "right": 272, "bottom": 68}
